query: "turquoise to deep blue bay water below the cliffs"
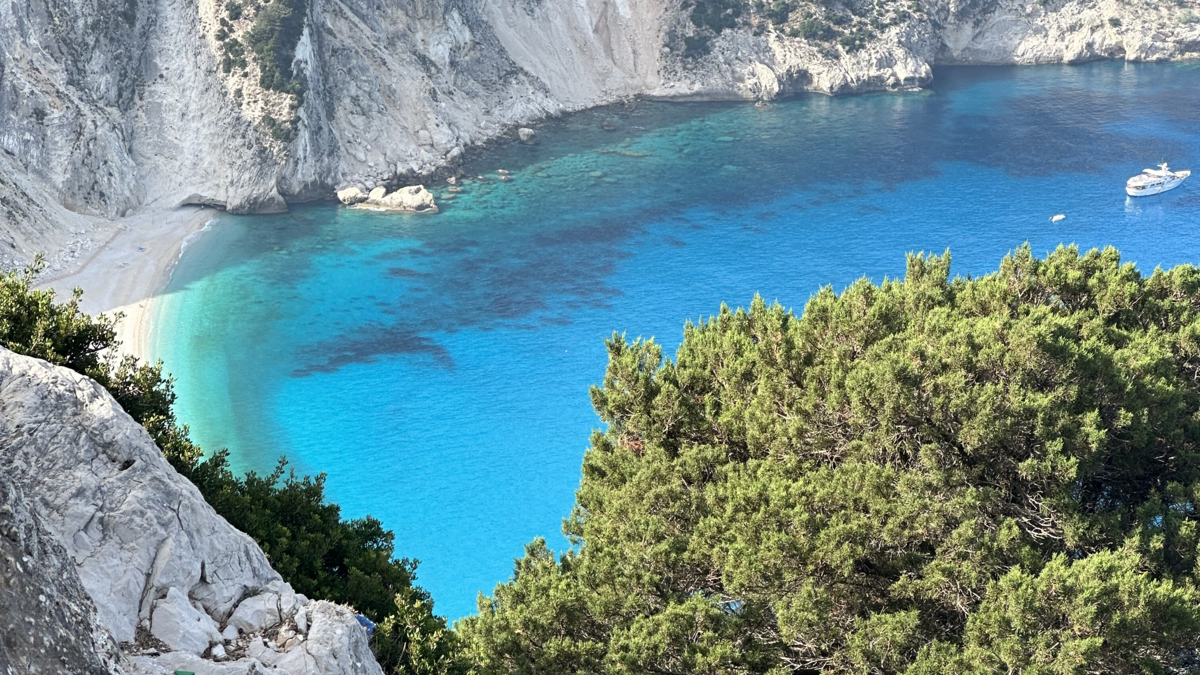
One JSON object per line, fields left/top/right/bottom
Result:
{"left": 154, "top": 64, "right": 1200, "bottom": 617}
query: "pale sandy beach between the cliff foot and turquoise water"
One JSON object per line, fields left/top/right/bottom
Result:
{"left": 36, "top": 207, "right": 220, "bottom": 362}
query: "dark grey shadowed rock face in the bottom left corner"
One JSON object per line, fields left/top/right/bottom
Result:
{"left": 0, "top": 476, "right": 120, "bottom": 675}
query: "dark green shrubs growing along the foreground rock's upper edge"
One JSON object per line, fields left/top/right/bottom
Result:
{"left": 0, "top": 262, "right": 461, "bottom": 675}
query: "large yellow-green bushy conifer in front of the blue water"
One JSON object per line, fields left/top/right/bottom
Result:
{"left": 457, "top": 247, "right": 1200, "bottom": 675}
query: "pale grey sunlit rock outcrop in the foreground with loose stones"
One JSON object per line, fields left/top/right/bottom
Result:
{"left": 0, "top": 350, "right": 380, "bottom": 675}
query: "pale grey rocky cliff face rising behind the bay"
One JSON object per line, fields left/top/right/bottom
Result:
{"left": 0, "top": 0, "right": 1200, "bottom": 265}
